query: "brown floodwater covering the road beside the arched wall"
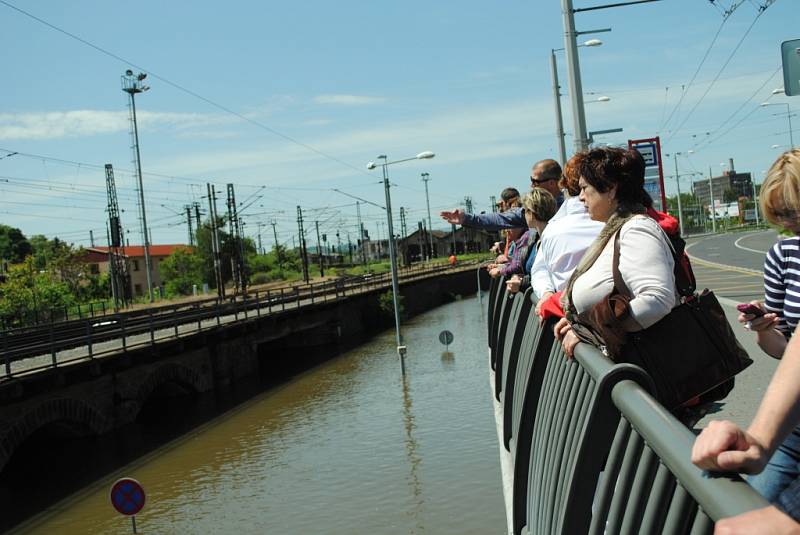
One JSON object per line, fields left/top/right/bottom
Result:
{"left": 14, "top": 298, "right": 505, "bottom": 534}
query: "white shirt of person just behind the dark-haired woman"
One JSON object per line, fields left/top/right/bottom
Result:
{"left": 531, "top": 197, "right": 603, "bottom": 313}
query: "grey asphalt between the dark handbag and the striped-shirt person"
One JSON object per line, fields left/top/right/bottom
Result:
{"left": 687, "top": 230, "right": 778, "bottom": 428}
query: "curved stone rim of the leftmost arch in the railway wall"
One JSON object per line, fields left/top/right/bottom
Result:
{"left": 0, "top": 398, "right": 111, "bottom": 471}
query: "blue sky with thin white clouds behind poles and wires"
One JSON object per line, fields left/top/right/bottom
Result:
{"left": 0, "top": 0, "right": 800, "bottom": 247}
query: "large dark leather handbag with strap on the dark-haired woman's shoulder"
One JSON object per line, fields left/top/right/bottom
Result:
{"left": 576, "top": 229, "right": 753, "bottom": 410}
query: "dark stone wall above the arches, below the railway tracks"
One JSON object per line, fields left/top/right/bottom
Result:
{"left": 0, "top": 269, "right": 476, "bottom": 471}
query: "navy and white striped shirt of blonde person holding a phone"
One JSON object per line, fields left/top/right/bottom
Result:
{"left": 764, "top": 237, "right": 800, "bottom": 338}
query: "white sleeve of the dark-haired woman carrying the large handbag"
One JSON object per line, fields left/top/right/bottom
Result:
{"left": 619, "top": 218, "right": 676, "bottom": 329}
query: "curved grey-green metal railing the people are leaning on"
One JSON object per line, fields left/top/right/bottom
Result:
{"left": 489, "top": 281, "right": 767, "bottom": 534}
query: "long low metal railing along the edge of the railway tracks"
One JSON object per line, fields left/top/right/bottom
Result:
{"left": 0, "top": 262, "right": 472, "bottom": 379}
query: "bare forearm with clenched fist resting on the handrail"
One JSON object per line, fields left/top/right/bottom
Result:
{"left": 692, "top": 336, "right": 800, "bottom": 474}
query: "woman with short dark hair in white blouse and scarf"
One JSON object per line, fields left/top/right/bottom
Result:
{"left": 555, "top": 147, "right": 678, "bottom": 357}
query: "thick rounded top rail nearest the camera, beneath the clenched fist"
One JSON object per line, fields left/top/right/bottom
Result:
{"left": 611, "top": 380, "right": 769, "bottom": 520}
